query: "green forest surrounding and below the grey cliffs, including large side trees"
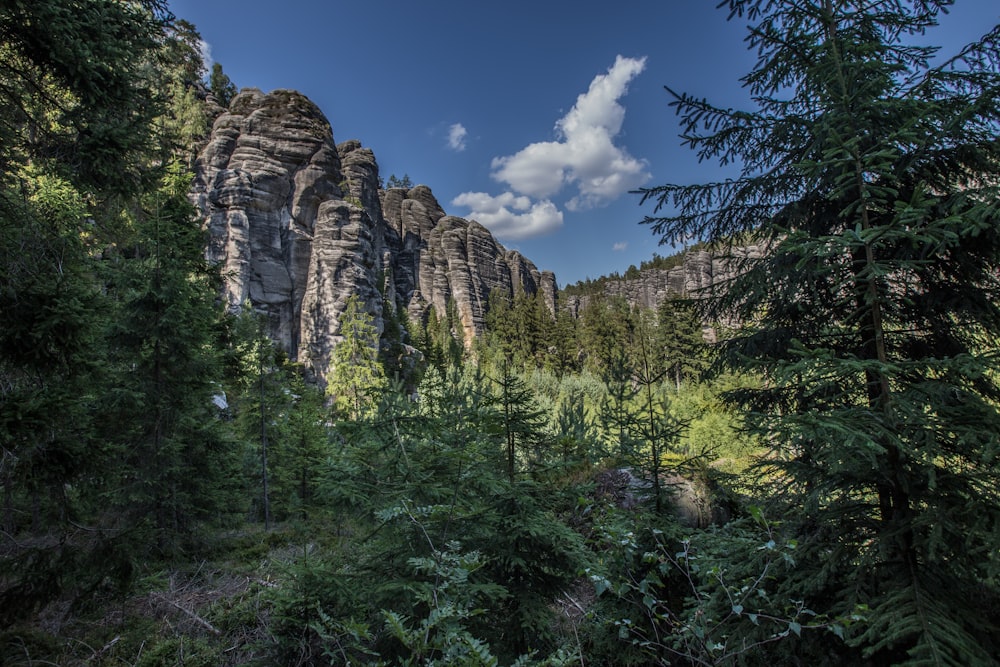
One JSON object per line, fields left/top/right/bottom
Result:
{"left": 0, "top": 0, "right": 1000, "bottom": 667}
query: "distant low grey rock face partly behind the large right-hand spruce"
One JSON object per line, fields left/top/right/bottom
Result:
{"left": 562, "top": 246, "right": 762, "bottom": 317}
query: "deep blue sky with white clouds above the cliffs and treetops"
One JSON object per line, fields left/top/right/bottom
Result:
{"left": 169, "top": 0, "right": 1000, "bottom": 286}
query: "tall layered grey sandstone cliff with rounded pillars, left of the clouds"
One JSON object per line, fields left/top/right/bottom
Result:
{"left": 192, "top": 89, "right": 556, "bottom": 377}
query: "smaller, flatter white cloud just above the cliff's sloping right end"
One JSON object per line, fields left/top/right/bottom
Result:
{"left": 451, "top": 192, "right": 563, "bottom": 241}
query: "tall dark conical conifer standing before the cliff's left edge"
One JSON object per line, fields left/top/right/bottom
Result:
{"left": 106, "top": 165, "right": 240, "bottom": 555}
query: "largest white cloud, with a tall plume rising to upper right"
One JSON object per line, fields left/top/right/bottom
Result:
{"left": 491, "top": 56, "right": 650, "bottom": 210}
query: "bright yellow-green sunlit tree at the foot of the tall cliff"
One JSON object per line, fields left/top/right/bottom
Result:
{"left": 326, "top": 294, "right": 387, "bottom": 419}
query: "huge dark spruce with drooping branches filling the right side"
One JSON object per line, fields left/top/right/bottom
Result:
{"left": 642, "top": 0, "right": 1000, "bottom": 665}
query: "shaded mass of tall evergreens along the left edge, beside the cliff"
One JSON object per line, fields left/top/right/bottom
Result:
{"left": 0, "top": 0, "right": 238, "bottom": 620}
